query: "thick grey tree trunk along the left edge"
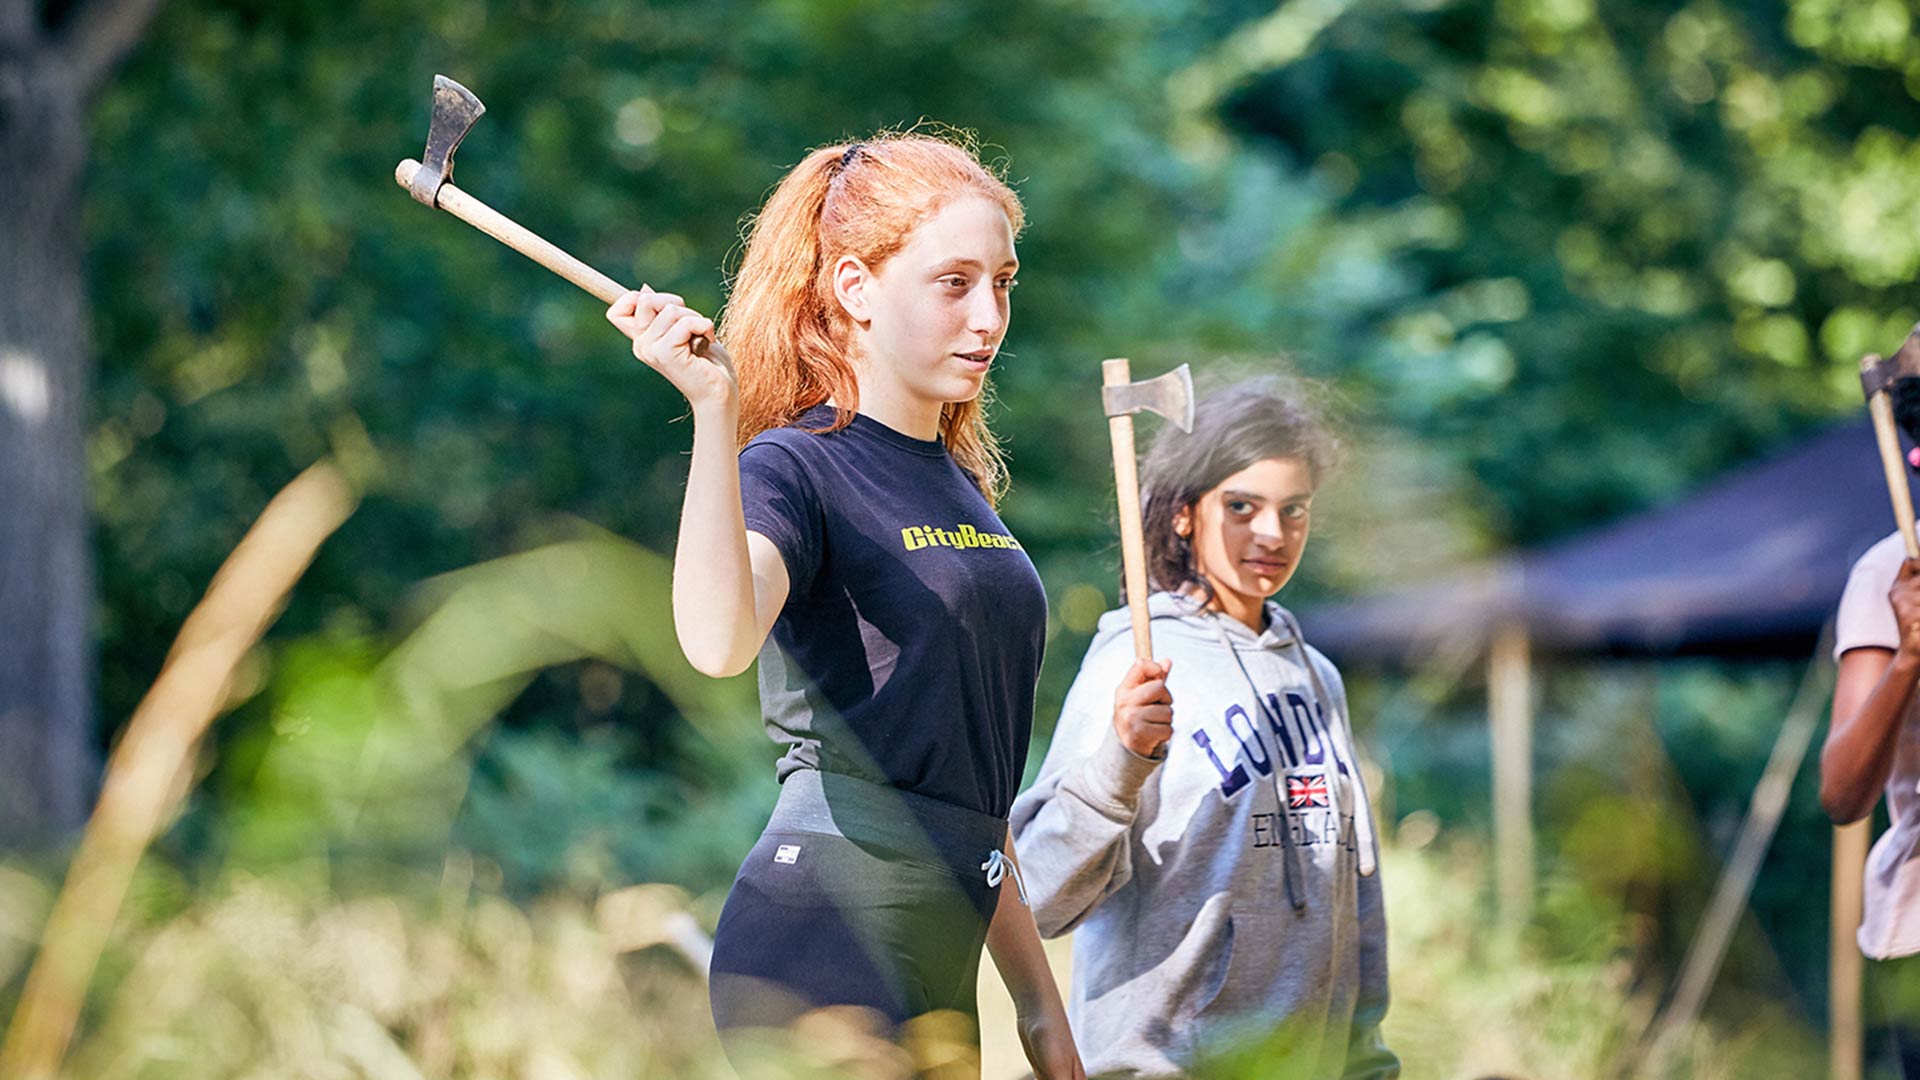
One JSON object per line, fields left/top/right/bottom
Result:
{"left": 0, "top": 0, "right": 98, "bottom": 847}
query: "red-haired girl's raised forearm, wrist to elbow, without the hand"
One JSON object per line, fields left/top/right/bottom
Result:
{"left": 674, "top": 404, "right": 760, "bottom": 676}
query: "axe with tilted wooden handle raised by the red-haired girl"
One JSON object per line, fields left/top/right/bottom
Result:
{"left": 394, "top": 75, "right": 707, "bottom": 356}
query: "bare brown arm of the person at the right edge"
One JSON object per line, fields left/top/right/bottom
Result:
{"left": 1820, "top": 559, "right": 1920, "bottom": 824}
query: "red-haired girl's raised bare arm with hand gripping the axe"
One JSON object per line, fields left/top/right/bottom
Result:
{"left": 607, "top": 288, "right": 789, "bottom": 676}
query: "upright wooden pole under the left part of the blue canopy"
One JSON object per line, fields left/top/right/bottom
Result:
{"left": 1486, "top": 623, "right": 1534, "bottom": 930}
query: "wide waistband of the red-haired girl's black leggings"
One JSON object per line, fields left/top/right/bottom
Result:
{"left": 766, "top": 769, "right": 1006, "bottom": 871}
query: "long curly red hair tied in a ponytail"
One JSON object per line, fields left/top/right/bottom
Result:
{"left": 716, "top": 133, "right": 1025, "bottom": 503}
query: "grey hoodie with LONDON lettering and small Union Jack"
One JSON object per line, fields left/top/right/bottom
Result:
{"left": 1012, "top": 592, "right": 1400, "bottom": 1080}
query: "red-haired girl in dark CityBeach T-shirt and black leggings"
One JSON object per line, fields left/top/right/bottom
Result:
{"left": 607, "top": 135, "right": 1083, "bottom": 1076}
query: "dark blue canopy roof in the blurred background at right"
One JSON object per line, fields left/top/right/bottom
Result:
{"left": 1302, "top": 415, "right": 1895, "bottom": 665}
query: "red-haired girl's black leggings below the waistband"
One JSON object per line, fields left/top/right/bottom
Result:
{"left": 710, "top": 828, "right": 998, "bottom": 1032}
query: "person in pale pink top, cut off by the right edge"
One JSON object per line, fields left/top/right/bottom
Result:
{"left": 1820, "top": 379, "right": 1920, "bottom": 1078}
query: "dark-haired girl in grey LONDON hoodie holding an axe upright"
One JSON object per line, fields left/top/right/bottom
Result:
{"left": 1012, "top": 379, "right": 1400, "bottom": 1080}
